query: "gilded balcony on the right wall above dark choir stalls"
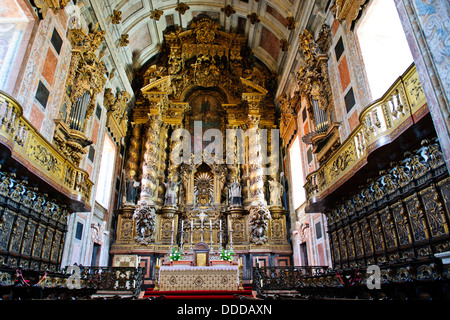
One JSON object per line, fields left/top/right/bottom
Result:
{"left": 304, "top": 64, "right": 428, "bottom": 203}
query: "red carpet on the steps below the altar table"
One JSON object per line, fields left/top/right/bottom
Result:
{"left": 143, "top": 288, "right": 252, "bottom": 299}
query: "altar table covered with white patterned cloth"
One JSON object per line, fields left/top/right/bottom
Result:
{"left": 159, "top": 265, "right": 239, "bottom": 291}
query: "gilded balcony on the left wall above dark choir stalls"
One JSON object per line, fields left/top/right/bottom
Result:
{"left": 0, "top": 91, "right": 93, "bottom": 211}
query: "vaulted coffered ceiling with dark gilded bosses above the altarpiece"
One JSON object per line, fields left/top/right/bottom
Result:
{"left": 84, "top": 0, "right": 330, "bottom": 96}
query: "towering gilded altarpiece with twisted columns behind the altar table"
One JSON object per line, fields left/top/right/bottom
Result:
{"left": 111, "top": 16, "right": 292, "bottom": 283}
